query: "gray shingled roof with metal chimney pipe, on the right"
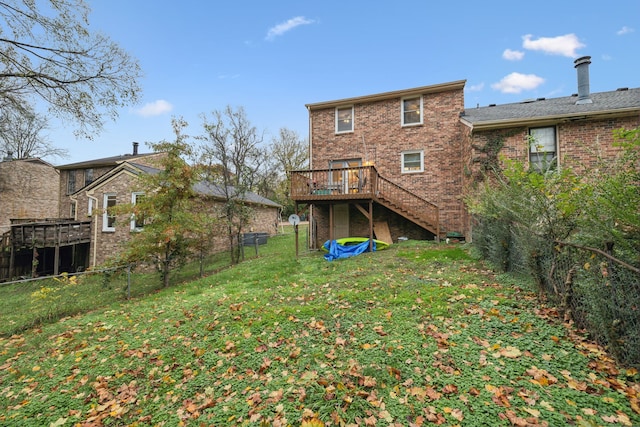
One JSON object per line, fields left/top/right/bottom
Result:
{"left": 460, "top": 88, "right": 640, "bottom": 129}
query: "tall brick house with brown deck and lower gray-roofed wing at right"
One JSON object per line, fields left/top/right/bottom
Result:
{"left": 290, "top": 57, "right": 640, "bottom": 248}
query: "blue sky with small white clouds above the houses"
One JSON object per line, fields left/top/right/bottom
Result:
{"left": 48, "top": 0, "right": 640, "bottom": 164}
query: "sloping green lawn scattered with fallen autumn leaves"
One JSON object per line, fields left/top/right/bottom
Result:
{"left": 0, "top": 231, "right": 640, "bottom": 426}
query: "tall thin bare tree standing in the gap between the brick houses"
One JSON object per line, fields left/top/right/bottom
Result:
{"left": 202, "top": 106, "right": 266, "bottom": 264}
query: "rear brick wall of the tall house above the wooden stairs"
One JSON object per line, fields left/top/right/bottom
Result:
{"left": 310, "top": 89, "right": 466, "bottom": 239}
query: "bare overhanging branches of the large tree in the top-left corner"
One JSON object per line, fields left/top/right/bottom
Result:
{"left": 0, "top": 0, "right": 141, "bottom": 138}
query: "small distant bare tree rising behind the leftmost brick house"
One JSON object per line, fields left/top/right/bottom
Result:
{"left": 0, "top": 109, "right": 69, "bottom": 159}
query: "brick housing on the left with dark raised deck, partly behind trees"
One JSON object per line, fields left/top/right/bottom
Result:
{"left": 0, "top": 142, "right": 281, "bottom": 281}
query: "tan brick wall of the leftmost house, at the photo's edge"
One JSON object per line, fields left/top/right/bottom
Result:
{"left": 0, "top": 160, "right": 59, "bottom": 234}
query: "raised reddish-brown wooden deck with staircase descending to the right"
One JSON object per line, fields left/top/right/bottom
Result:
{"left": 289, "top": 166, "right": 440, "bottom": 239}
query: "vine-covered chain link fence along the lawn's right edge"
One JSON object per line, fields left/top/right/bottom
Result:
{"left": 473, "top": 218, "right": 640, "bottom": 367}
